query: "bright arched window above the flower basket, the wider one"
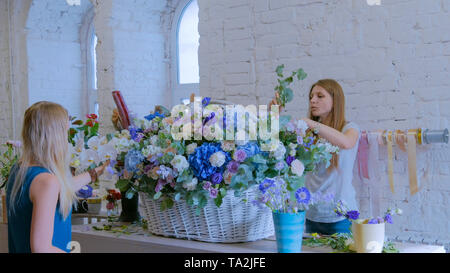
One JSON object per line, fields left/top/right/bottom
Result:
{"left": 172, "top": 0, "right": 200, "bottom": 105}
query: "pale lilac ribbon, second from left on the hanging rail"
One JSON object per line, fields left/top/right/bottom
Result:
{"left": 367, "top": 132, "right": 383, "bottom": 215}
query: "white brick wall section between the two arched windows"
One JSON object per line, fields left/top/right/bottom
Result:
{"left": 94, "top": 0, "right": 178, "bottom": 134}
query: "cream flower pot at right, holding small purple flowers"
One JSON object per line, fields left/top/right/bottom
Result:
{"left": 352, "top": 222, "right": 385, "bottom": 253}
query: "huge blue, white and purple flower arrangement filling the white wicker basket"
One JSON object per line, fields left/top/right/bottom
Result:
{"left": 111, "top": 64, "right": 338, "bottom": 212}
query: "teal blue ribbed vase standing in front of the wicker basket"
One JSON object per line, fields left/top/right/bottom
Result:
{"left": 272, "top": 211, "right": 305, "bottom": 253}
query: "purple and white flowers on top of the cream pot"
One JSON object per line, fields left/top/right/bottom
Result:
{"left": 334, "top": 200, "right": 402, "bottom": 224}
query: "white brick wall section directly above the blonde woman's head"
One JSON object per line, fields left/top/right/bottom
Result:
{"left": 27, "top": 0, "right": 92, "bottom": 118}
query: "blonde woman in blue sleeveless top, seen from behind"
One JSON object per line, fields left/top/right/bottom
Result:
{"left": 6, "top": 101, "right": 105, "bottom": 253}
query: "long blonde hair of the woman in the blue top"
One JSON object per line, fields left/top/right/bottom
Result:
{"left": 10, "top": 101, "right": 77, "bottom": 219}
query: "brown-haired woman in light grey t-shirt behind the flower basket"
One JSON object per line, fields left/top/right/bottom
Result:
{"left": 270, "top": 79, "right": 360, "bottom": 235}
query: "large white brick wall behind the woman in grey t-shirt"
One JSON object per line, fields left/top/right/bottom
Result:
{"left": 198, "top": 0, "right": 450, "bottom": 246}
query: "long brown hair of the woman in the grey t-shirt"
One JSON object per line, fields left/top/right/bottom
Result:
{"left": 308, "top": 79, "right": 346, "bottom": 170}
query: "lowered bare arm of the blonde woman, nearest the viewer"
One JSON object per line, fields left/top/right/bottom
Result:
{"left": 30, "top": 173, "right": 66, "bottom": 253}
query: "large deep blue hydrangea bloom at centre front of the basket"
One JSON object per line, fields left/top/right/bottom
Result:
{"left": 188, "top": 143, "right": 231, "bottom": 181}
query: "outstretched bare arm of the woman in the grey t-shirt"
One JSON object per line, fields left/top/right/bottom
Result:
{"left": 303, "top": 118, "right": 358, "bottom": 149}
